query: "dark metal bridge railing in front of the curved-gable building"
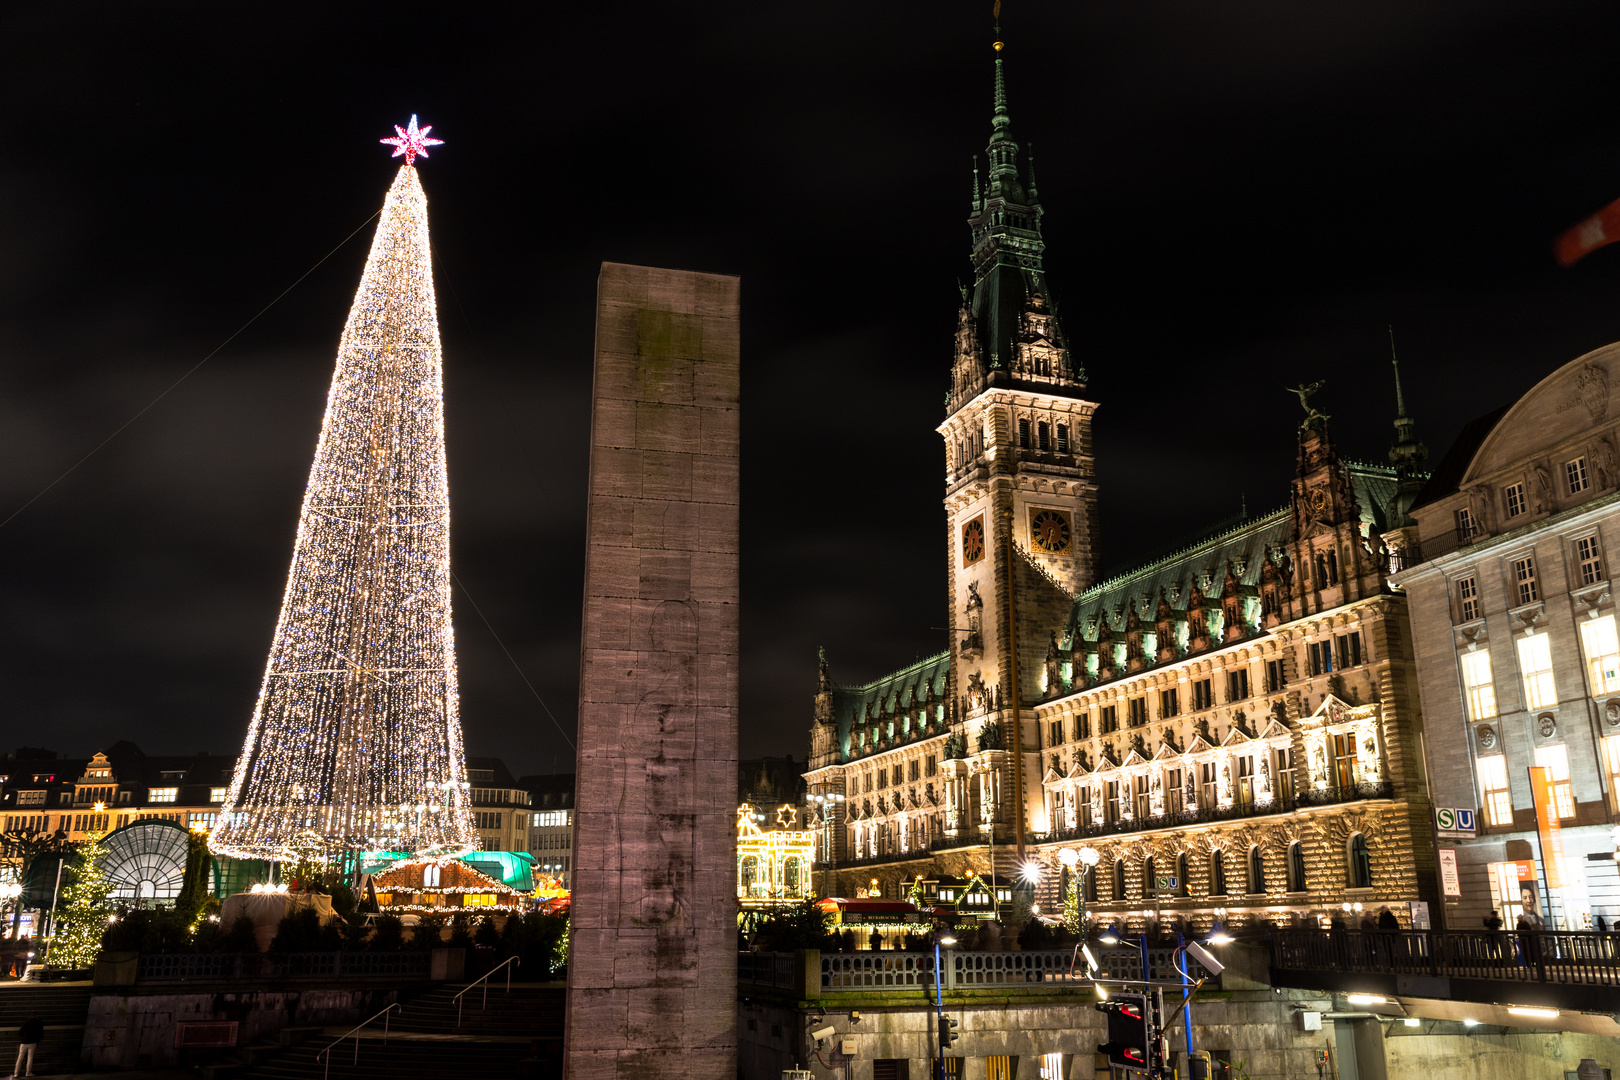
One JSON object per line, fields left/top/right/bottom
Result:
{"left": 1272, "top": 929, "right": 1620, "bottom": 986}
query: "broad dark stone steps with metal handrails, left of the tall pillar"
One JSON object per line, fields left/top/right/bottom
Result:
{"left": 231, "top": 976, "right": 565, "bottom": 1080}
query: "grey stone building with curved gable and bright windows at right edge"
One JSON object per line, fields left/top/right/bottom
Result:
{"left": 1398, "top": 345, "right": 1620, "bottom": 929}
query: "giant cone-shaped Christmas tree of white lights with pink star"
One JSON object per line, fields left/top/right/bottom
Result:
{"left": 209, "top": 117, "right": 475, "bottom": 861}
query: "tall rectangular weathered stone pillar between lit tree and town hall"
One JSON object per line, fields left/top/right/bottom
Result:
{"left": 564, "top": 262, "right": 740, "bottom": 1080}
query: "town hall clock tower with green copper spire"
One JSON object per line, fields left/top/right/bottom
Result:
{"left": 938, "top": 42, "right": 1097, "bottom": 731}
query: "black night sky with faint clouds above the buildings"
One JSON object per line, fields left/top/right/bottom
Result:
{"left": 0, "top": 0, "right": 1620, "bottom": 772}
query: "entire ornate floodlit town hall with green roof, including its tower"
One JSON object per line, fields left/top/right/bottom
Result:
{"left": 805, "top": 44, "right": 1439, "bottom": 925}
